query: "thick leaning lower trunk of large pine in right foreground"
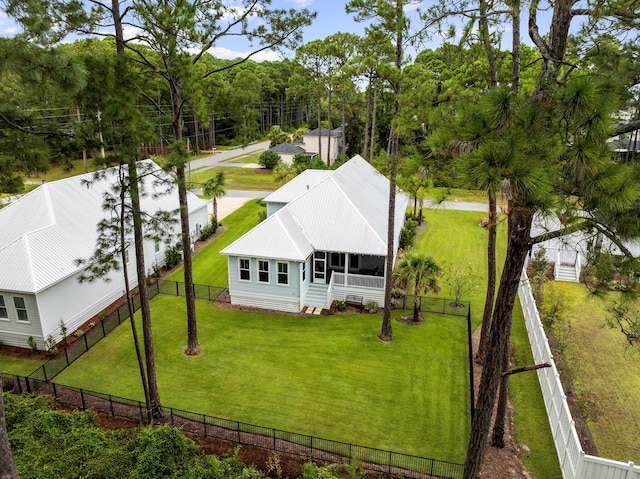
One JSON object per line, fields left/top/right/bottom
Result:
{"left": 463, "top": 208, "right": 534, "bottom": 479}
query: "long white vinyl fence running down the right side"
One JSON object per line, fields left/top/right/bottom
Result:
{"left": 518, "top": 271, "right": 640, "bottom": 479}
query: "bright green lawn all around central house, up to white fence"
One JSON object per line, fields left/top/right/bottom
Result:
{"left": 52, "top": 202, "right": 561, "bottom": 479}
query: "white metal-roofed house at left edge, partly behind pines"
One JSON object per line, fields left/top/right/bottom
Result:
{"left": 0, "top": 160, "right": 209, "bottom": 349}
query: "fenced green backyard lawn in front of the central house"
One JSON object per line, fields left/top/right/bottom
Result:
{"left": 56, "top": 296, "right": 469, "bottom": 462}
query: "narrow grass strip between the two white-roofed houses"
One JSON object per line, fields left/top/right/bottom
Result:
{"left": 165, "top": 200, "right": 265, "bottom": 287}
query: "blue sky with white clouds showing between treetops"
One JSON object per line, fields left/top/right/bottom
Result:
{"left": 0, "top": 0, "right": 552, "bottom": 61}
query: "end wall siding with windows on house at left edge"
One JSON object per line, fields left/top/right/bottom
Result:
{"left": 0, "top": 291, "right": 44, "bottom": 349}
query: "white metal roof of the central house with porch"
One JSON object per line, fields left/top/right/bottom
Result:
{"left": 222, "top": 156, "right": 408, "bottom": 261}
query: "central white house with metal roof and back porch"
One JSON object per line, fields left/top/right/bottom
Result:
{"left": 221, "top": 156, "right": 409, "bottom": 312}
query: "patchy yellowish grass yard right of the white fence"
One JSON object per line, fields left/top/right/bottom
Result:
{"left": 545, "top": 282, "right": 640, "bottom": 464}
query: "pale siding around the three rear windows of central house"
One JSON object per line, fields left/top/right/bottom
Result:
{"left": 228, "top": 256, "right": 302, "bottom": 313}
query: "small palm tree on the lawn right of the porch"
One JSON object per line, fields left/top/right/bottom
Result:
{"left": 394, "top": 249, "right": 442, "bottom": 323}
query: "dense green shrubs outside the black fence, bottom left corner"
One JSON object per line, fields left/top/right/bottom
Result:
{"left": 4, "top": 394, "right": 264, "bottom": 479}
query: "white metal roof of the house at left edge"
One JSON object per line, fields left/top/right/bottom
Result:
{"left": 0, "top": 160, "right": 208, "bottom": 293}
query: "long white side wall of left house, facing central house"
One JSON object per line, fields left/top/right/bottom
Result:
{"left": 37, "top": 268, "right": 130, "bottom": 342}
